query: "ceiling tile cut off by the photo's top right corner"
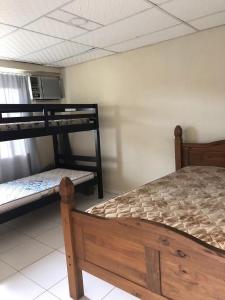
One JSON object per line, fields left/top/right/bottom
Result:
{"left": 161, "top": 0, "right": 225, "bottom": 21}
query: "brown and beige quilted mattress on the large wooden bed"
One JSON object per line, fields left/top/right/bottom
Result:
{"left": 87, "top": 167, "right": 225, "bottom": 250}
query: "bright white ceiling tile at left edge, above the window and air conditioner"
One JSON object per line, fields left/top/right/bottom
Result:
{"left": 0, "top": 29, "right": 60, "bottom": 58}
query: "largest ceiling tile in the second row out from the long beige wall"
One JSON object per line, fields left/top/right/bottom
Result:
{"left": 74, "top": 8, "right": 180, "bottom": 48}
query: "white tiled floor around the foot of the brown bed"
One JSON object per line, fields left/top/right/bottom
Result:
{"left": 0, "top": 193, "right": 137, "bottom": 300}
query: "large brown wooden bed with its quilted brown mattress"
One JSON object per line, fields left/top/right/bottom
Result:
{"left": 60, "top": 126, "right": 225, "bottom": 300}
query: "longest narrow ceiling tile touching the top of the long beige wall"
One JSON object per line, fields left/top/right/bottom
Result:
{"left": 107, "top": 24, "right": 195, "bottom": 52}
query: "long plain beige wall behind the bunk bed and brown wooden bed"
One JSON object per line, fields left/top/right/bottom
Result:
{"left": 64, "top": 27, "right": 225, "bottom": 191}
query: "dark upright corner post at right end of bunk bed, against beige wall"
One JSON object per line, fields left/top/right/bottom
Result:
{"left": 95, "top": 104, "right": 103, "bottom": 199}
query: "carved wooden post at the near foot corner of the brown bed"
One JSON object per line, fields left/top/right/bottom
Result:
{"left": 59, "top": 177, "right": 84, "bottom": 300}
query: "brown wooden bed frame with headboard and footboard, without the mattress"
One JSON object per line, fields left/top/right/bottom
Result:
{"left": 60, "top": 126, "right": 225, "bottom": 300}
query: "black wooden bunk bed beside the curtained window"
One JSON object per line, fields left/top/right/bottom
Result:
{"left": 0, "top": 104, "right": 103, "bottom": 223}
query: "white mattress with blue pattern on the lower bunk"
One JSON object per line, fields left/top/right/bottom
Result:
{"left": 0, "top": 169, "right": 94, "bottom": 213}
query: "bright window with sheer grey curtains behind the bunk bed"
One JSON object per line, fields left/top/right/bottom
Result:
{"left": 0, "top": 73, "right": 40, "bottom": 182}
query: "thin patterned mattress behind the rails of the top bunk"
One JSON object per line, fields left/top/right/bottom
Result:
{"left": 0, "top": 118, "right": 90, "bottom": 131}
